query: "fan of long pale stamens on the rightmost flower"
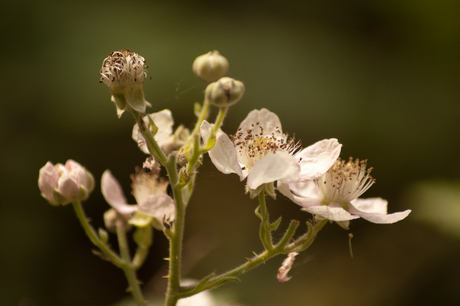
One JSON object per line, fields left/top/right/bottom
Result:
{"left": 315, "top": 157, "right": 375, "bottom": 205}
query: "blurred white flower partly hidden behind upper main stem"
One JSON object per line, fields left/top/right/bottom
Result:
{"left": 132, "top": 109, "right": 190, "bottom": 154}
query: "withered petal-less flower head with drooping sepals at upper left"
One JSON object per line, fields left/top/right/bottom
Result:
{"left": 99, "top": 50, "right": 151, "bottom": 117}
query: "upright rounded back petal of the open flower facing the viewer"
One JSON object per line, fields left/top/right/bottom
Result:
{"left": 240, "top": 108, "right": 284, "bottom": 139}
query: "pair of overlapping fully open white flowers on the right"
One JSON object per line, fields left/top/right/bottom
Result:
{"left": 201, "top": 109, "right": 410, "bottom": 227}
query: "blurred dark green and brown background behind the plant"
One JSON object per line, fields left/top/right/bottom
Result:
{"left": 0, "top": 0, "right": 460, "bottom": 306}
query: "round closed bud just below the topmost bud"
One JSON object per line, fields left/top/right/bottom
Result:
{"left": 205, "top": 77, "right": 244, "bottom": 107}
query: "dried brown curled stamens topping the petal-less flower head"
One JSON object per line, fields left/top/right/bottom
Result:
{"left": 99, "top": 50, "right": 147, "bottom": 87}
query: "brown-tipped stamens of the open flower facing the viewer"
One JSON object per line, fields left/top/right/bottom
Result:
{"left": 230, "top": 122, "right": 302, "bottom": 169}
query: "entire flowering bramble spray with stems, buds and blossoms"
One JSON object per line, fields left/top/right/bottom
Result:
{"left": 38, "top": 50, "right": 411, "bottom": 306}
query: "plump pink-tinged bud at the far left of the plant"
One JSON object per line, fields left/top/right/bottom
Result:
{"left": 38, "top": 159, "right": 94, "bottom": 206}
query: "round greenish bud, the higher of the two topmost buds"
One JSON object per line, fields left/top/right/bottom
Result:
{"left": 192, "top": 50, "right": 228, "bottom": 83}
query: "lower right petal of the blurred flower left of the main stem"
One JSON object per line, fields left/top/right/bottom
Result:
{"left": 138, "top": 194, "right": 176, "bottom": 221}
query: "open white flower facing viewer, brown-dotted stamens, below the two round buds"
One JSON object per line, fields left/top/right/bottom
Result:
{"left": 201, "top": 109, "right": 342, "bottom": 190}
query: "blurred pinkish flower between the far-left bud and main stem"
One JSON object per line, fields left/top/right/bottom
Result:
{"left": 101, "top": 170, "right": 175, "bottom": 230}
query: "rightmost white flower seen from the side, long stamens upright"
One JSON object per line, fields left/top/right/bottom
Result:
{"left": 278, "top": 158, "right": 411, "bottom": 228}
